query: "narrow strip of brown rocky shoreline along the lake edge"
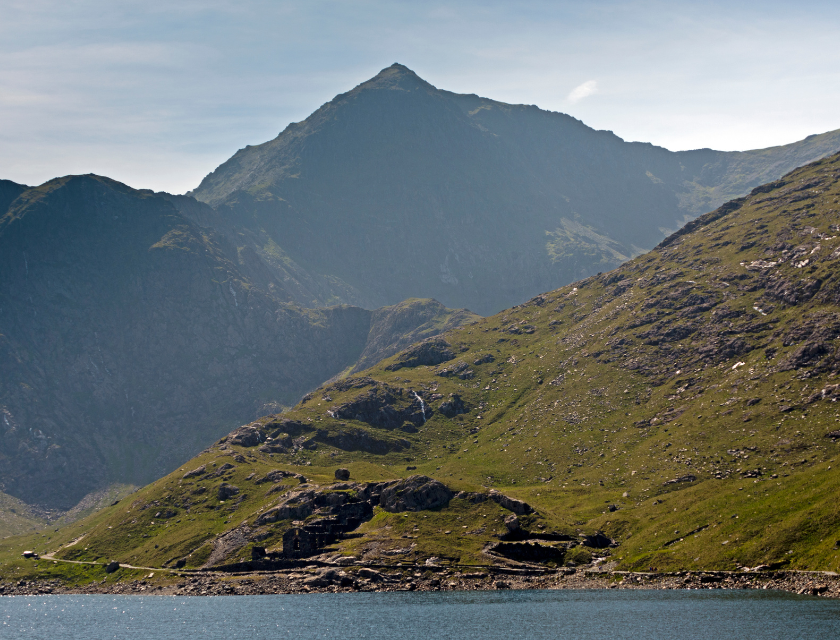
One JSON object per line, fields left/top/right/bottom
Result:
{"left": 0, "top": 567, "right": 840, "bottom": 598}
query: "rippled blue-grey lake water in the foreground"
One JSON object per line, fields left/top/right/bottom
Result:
{"left": 0, "top": 590, "right": 840, "bottom": 640}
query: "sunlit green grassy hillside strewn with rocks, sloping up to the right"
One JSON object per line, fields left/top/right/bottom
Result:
{"left": 56, "top": 154, "right": 840, "bottom": 571}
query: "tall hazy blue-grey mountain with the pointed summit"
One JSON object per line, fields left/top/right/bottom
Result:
{"left": 193, "top": 64, "right": 840, "bottom": 315}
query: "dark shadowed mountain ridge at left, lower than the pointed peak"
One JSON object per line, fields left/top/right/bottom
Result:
{"left": 0, "top": 176, "right": 475, "bottom": 509}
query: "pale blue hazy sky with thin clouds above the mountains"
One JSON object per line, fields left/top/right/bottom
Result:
{"left": 0, "top": 0, "right": 840, "bottom": 193}
